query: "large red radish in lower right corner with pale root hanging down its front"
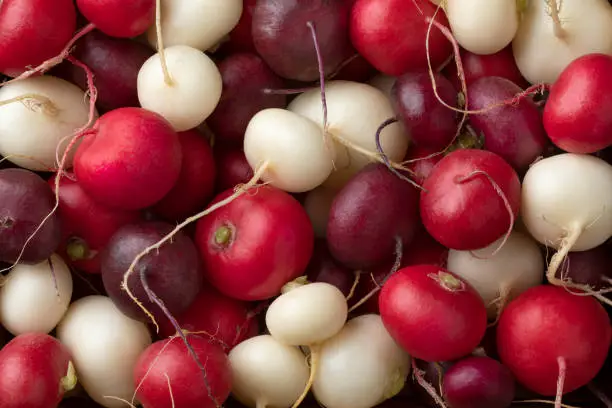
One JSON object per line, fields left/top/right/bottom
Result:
{"left": 497, "top": 285, "right": 612, "bottom": 396}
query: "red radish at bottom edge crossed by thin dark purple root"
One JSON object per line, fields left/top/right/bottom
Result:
{"left": 134, "top": 335, "right": 232, "bottom": 408}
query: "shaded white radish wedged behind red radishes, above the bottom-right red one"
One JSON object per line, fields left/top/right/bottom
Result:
{"left": 447, "top": 231, "right": 545, "bottom": 317}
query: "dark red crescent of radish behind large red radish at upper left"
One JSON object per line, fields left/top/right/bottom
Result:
{"left": 153, "top": 130, "right": 217, "bottom": 222}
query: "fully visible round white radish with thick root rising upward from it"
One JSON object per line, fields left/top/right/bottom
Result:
{"left": 138, "top": 45, "right": 222, "bottom": 131}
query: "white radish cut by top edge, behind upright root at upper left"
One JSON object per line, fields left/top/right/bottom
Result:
{"left": 147, "top": 0, "right": 243, "bottom": 51}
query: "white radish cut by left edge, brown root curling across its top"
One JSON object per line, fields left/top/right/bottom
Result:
{"left": 0, "top": 76, "right": 95, "bottom": 171}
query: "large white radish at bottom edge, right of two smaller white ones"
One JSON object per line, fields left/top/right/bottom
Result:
{"left": 313, "top": 314, "right": 410, "bottom": 408}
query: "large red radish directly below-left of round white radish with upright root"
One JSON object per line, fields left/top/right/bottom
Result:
{"left": 74, "top": 108, "right": 182, "bottom": 210}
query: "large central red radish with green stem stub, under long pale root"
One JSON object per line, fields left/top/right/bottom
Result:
{"left": 196, "top": 186, "right": 314, "bottom": 300}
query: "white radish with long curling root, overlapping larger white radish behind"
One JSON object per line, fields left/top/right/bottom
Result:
{"left": 244, "top": 108, "right": 334, "bottom": 193}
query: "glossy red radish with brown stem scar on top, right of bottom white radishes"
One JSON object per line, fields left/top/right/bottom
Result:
{"left": 379, "top": 265, "right": 487, "bottom": 361}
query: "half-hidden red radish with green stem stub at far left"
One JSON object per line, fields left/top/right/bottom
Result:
{"left": 49, "top": 175, "right": 141, "bottom": 273}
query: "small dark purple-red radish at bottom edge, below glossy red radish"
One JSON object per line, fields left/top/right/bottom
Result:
{"left": 442, "top": 357, "right": 515, "bottom": 408}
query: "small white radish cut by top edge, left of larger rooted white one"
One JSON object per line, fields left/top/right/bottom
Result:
{"left": 445, "top": 0, "right": 519, "bottom": 55}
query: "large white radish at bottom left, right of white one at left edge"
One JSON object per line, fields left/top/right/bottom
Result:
{"left": 57, "top": 296, "right": 151, "bottom": 408}
